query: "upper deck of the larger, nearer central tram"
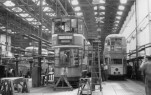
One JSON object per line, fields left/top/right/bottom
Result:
{"left": 52, "top": 16, "right": 85, "bottom": 48}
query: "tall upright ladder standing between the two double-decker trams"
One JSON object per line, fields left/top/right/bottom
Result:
{"left": 91, "top": 41, "right": 102, "bottom": 91}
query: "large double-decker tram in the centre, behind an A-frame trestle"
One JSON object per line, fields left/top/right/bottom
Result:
{"left": 52, "top": 16, "right": 86, "bottom": 86}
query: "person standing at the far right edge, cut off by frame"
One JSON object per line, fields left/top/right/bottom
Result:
{"left": 140, "top": 56, "right": 151, "bottom": 95}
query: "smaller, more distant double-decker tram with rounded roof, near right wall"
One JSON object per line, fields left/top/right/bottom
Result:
{"left": 103, "top": 34, "right": 126, "bottom": 78}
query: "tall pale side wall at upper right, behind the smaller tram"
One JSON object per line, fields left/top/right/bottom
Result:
{"left": 120, "top": 0, "right": 151, "bottom": 57}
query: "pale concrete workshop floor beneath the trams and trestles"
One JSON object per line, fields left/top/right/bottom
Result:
{"left": 15, "top": 80, "right": 146, "bottom": 95}
